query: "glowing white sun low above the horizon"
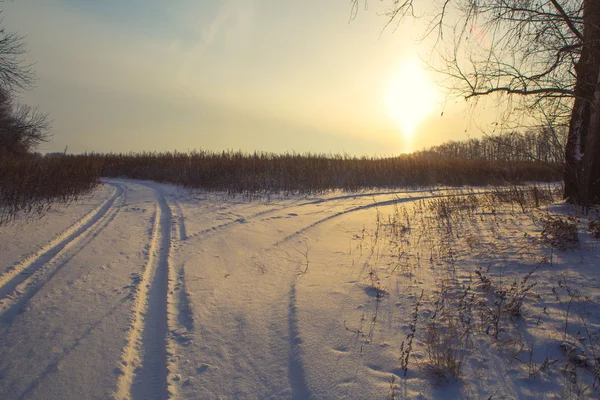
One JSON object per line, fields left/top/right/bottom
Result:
{"left": 386, "top": 59, "right": 438, "bottom": 137}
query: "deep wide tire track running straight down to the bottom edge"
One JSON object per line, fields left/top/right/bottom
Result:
{"left": 115, "top": 185, "right": 176, "bottom": 400}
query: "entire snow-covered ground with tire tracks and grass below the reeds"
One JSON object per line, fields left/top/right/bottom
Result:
{"left": 0, "top": 180, "right": 600, "bottom": 400}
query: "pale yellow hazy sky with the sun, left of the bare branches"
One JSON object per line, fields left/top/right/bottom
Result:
{"left": 2, "top": 0, "right": 496, "bottom": 156}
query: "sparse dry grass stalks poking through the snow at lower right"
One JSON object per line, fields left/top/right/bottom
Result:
{"left": 344, "top": 185, "right": 600, "bottom": 398}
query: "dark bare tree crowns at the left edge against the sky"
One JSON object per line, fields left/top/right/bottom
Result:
{"left": 0, "top": 14, "right": 51, "bottom": 158}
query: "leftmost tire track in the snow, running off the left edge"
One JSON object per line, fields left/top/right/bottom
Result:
{"left": 0, "top": 183, "right": 125, "bottom": 312}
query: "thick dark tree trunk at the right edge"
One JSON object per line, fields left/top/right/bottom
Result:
{"left": 564, "top": 0, "right": 600, "bottom": 206}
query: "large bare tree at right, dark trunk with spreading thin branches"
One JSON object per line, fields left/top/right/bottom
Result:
{"left": 351, "top": 0, "right": 600, "bottom": 205}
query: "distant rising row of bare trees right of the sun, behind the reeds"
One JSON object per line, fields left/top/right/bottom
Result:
{"left": 419, "top": 127, "right": 567, "bottom": 164}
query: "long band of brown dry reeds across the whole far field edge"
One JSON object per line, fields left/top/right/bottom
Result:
{"left": 0, "top": 151, "right": 562, "bottom": 225}
